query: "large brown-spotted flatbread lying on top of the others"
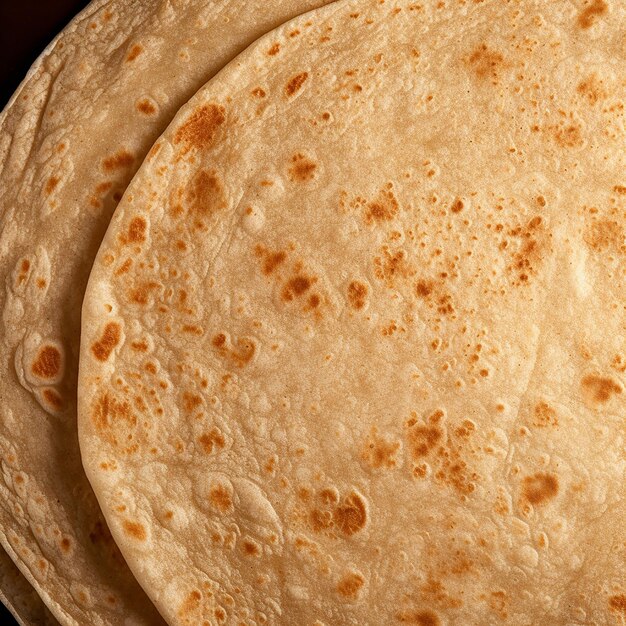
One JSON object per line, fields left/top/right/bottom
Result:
{"left": 79, "top": 0, "right": 626, "bottom": 626}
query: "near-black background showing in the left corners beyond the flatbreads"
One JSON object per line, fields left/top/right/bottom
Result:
{"left": 0, "top": 0, "right": 89, "bottom": 626}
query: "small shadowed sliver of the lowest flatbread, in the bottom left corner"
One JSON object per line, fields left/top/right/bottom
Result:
{"left": 0, "top": 550, "right": 58, "bottom": 626}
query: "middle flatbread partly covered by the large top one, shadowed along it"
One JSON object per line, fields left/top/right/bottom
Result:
{"left": 0, "top": 0, "right": 324, "bottom": 626}
